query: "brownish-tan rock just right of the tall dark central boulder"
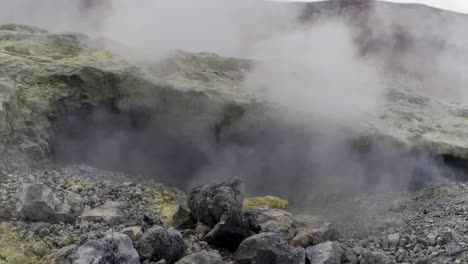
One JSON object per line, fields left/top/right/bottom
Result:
{"left": 245, "top": 206, "right": 296, "bottom": 240}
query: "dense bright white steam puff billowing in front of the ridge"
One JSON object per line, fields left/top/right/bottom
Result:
{"left": 245, "top": 20, "right": 384, "bottom": 122}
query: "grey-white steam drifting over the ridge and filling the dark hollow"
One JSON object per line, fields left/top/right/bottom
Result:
{"left": 0, "top": 0, "right": 468, "bottom": 206}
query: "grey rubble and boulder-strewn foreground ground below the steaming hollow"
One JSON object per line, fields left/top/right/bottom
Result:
{"left": 0, "top": 154, "right": 468, "bottom": 264}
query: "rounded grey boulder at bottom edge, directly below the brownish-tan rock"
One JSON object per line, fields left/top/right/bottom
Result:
{"left": 234, "top": 233, "right": 305, "bottom": 264}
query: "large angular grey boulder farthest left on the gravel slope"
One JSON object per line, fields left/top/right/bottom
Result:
{"left": 17, "top": 183, "right": 76, "bottom": 222}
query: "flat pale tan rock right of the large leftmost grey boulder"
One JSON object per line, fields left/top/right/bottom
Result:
{"left": 80, "top": 201, "right": 125, "bottom": 225}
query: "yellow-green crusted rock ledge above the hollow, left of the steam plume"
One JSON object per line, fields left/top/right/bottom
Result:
{"left": 0, "top": 25, "right": 249, "bottom": 161}
